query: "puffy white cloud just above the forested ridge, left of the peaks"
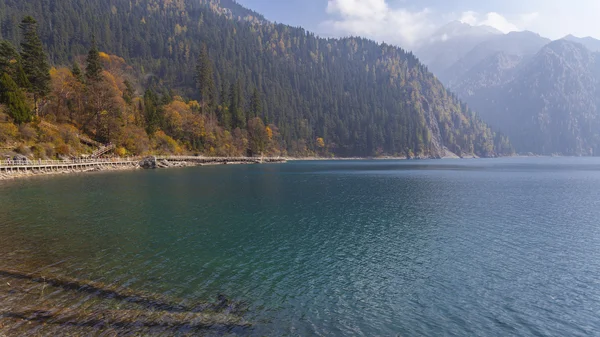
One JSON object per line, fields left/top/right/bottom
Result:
{"left": 322, "top": 0, "right": 435, "bottom": 48}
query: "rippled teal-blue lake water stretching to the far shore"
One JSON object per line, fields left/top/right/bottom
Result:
{"left": 0, "top": 158, "right": 600, "bottom": 336}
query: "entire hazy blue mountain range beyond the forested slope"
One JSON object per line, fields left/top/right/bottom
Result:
{"left": 424, "top": 20, "right": 600, "bottom": 155}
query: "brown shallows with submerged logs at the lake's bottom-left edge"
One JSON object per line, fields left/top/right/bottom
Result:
{"left": 0, "top": 269, "right": 251, "bottom": 331}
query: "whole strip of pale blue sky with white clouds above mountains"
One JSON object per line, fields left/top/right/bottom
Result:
{"left": 238, "top": 0, "right": 600, "bottom": 48}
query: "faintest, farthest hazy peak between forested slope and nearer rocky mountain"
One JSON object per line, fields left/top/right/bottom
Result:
{"left": 415, "top": 21, "right": 502, "bottom": 79}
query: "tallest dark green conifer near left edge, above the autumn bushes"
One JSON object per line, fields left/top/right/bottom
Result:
{"left": 19, "top": 16, "right": 50, "bottom": 113}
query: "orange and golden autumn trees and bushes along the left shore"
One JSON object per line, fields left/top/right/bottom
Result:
{"left": 0, "top": 45, "right": 282, "bottom": 158}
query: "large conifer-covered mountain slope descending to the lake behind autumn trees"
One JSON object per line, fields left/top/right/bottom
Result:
{"left": 0, "top": 0, "right": 511, "bottom": 157}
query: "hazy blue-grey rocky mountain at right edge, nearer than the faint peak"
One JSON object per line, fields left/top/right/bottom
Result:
{"left": 457, "top": 39, "right": 600, "bottom": 155}
